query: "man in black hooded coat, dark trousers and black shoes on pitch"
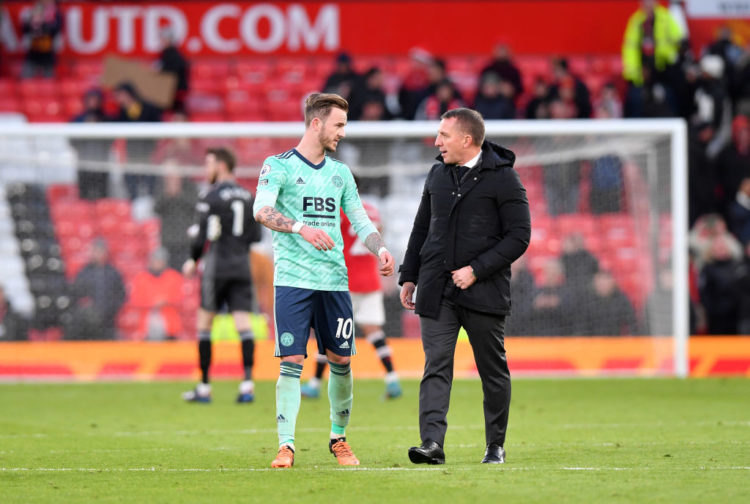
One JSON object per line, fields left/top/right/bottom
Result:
{"left": 399, "top": 108, "right": 531, "bottom": 464}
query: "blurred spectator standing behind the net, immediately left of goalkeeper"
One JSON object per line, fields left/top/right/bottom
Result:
{"left": 154, "top": 161, "right": 198, "bottom": 270}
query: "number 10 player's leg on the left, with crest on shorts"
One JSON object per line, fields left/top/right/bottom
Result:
{"left": 271, "top": 287, "right": 314, "bottom": 467}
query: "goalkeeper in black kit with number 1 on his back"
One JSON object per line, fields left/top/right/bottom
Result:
{"left": 182, "top": 147, "right": 260, "bottom": 403}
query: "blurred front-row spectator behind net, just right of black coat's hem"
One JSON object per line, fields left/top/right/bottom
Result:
{"left": 531, "top": 259, "right": 578, "bottom": 336}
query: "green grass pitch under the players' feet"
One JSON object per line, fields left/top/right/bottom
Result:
{"left": 0, "top": 379, "right": 750, "bottom": 504}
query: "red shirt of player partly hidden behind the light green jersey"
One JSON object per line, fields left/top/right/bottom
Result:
{"left": 341, "top": 202, "right": 381, "bottom": 293}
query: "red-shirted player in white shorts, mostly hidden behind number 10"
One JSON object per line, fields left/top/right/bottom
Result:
{"left": 301, "top": 201, "right": 402, "bottom": 399}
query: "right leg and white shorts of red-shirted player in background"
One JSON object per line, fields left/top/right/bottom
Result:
{"left": 352, "top": 291, "right": 402, "bottom": 399}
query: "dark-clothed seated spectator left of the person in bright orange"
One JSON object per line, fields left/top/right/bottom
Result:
{"left": 66, "top": 238, "right": 126, "bottom": 340}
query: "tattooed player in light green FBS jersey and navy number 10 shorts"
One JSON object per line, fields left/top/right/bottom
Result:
{"left": 253, "top": 93, "right": 394, "bottom": 467}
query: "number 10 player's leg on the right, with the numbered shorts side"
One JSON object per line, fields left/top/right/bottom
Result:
{"left": 313, "top": 291, "right": 359, "bottom": 465}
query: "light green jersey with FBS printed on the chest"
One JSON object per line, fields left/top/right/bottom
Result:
{"left": 253, "top": 149, "right": 377, "bottom": 291}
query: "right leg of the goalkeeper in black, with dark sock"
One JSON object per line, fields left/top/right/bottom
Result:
{"left": 227, "top": 279, "right": 255, "bottom": 403}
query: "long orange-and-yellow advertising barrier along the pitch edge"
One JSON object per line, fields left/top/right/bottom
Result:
{"left": 0, "top": 337, "right": 750, "bottom": 381}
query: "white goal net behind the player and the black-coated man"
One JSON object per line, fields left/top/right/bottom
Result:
{"left": 0, "top": 120, "right": 688, "bottom": 375}
